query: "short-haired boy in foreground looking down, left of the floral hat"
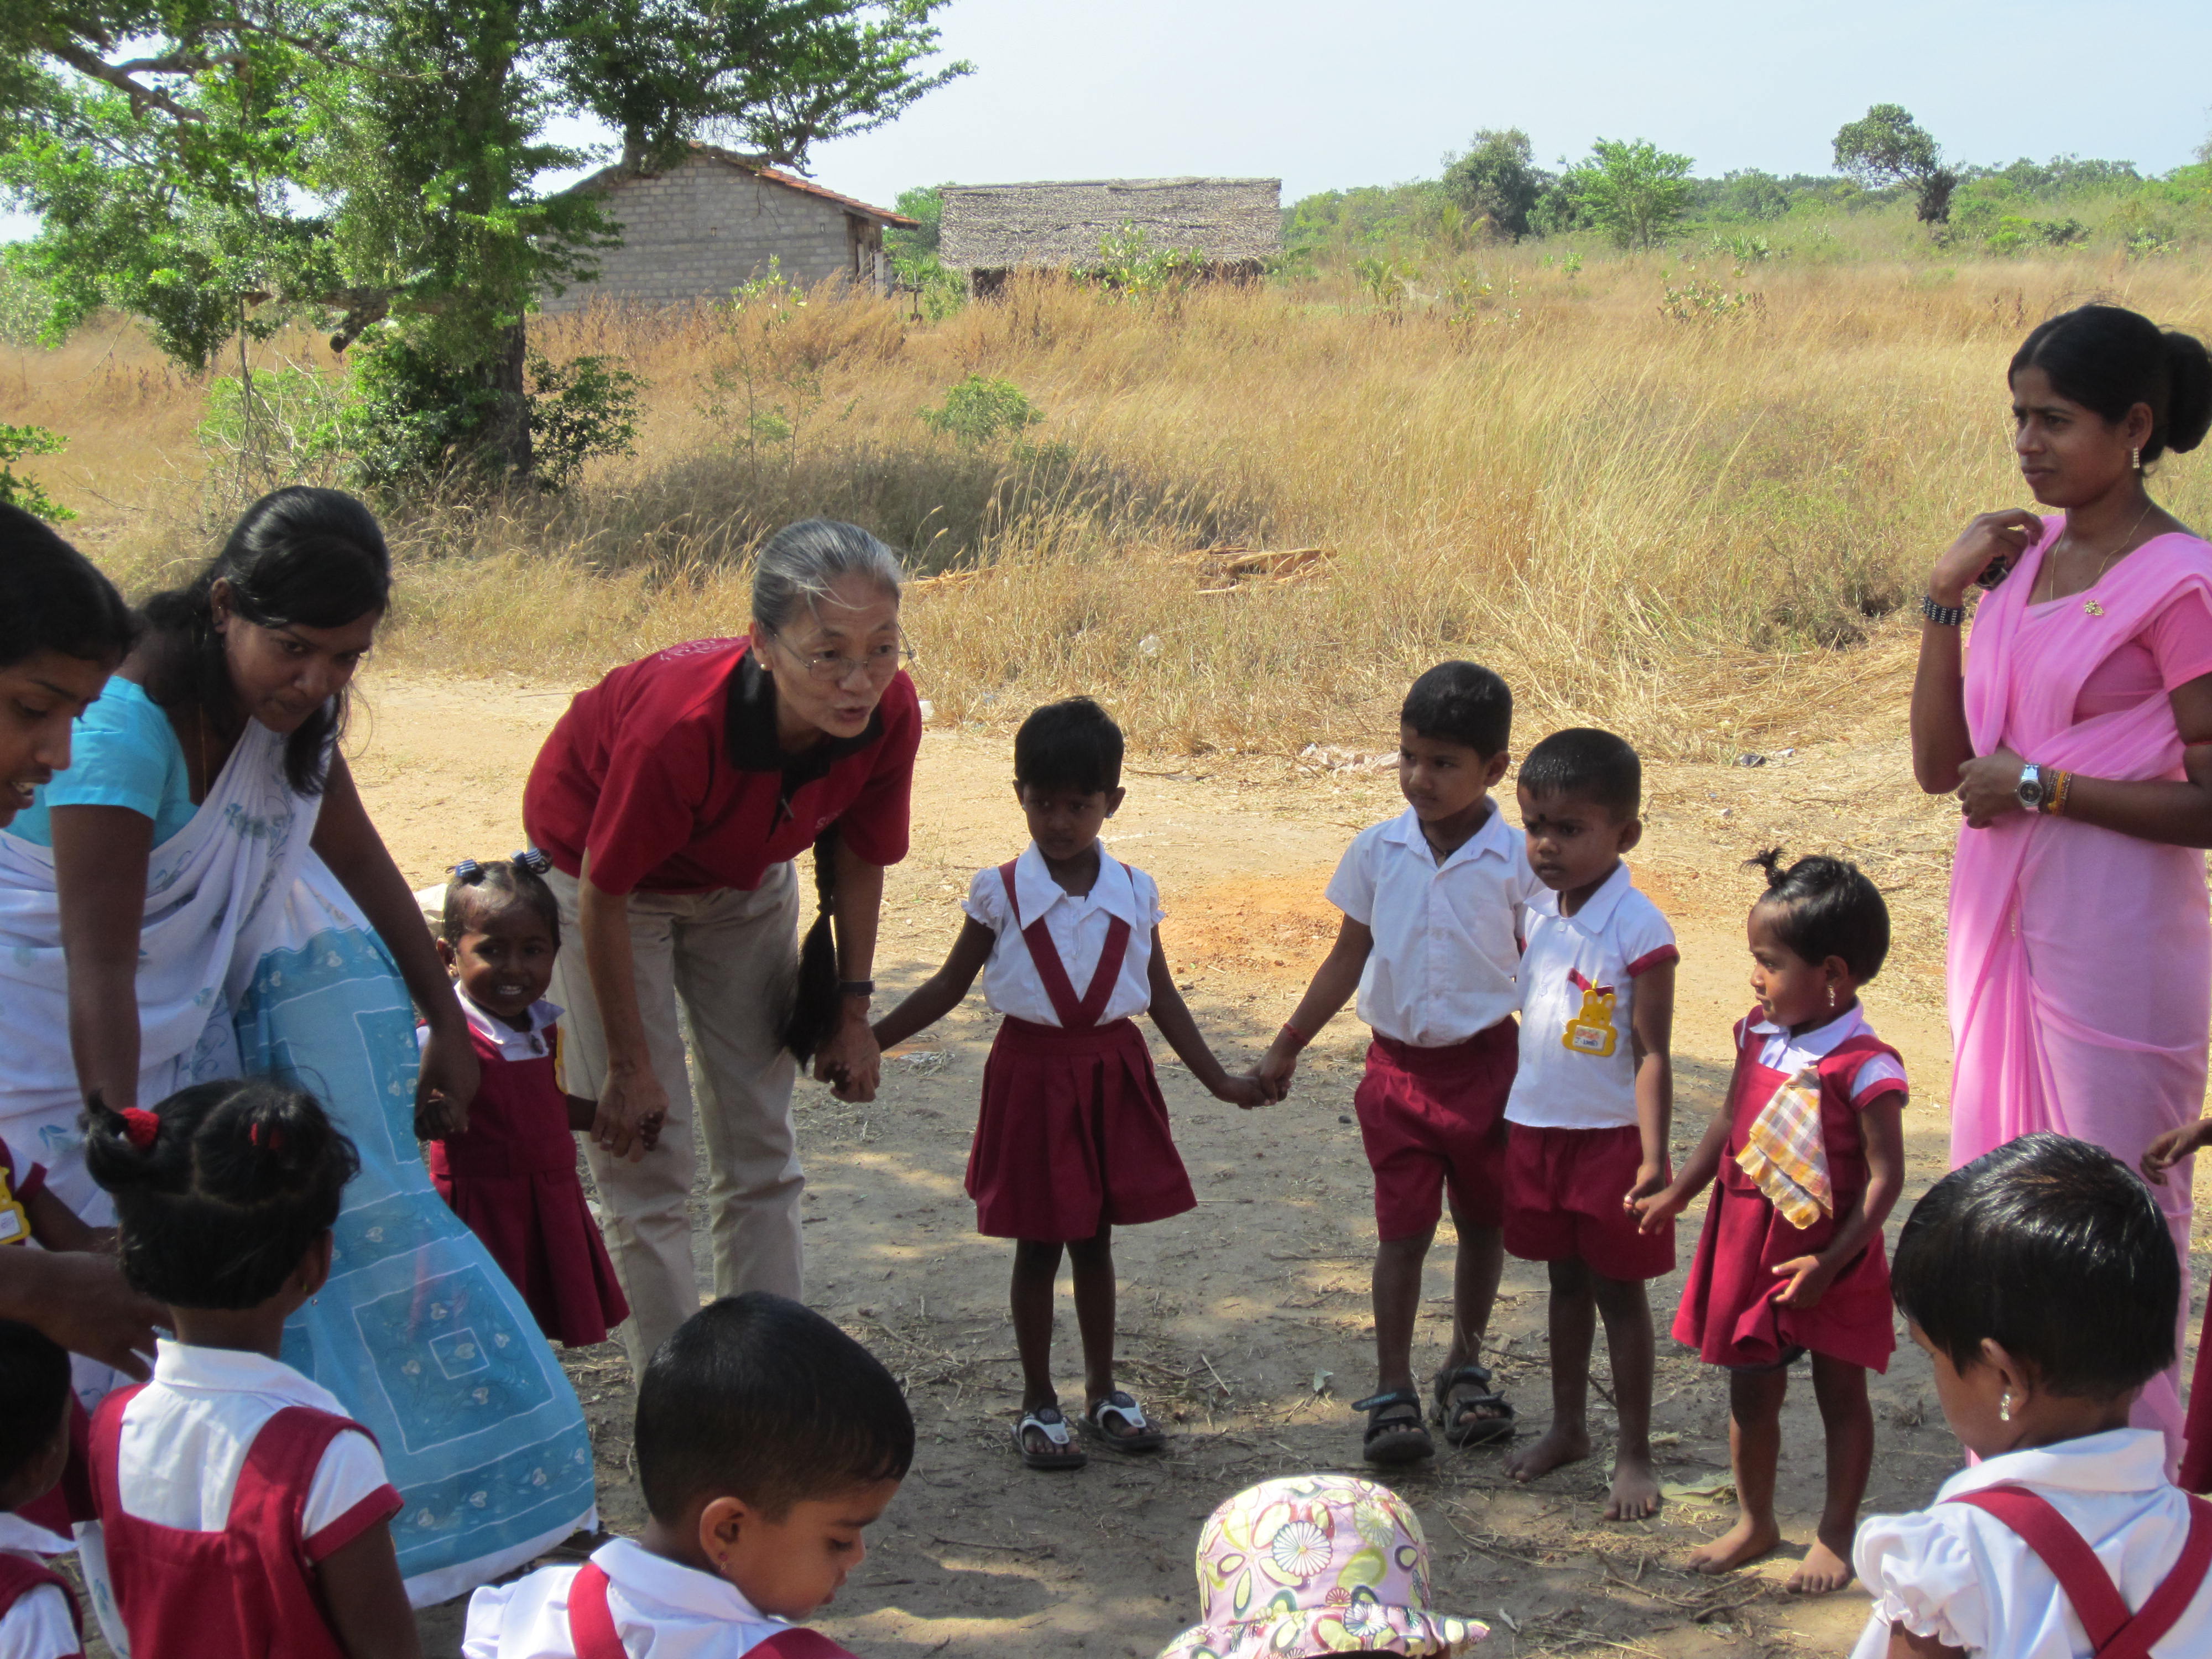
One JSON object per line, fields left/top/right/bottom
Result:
{"left": 460, "top": 1290, "right": 914, "bottom": 1659}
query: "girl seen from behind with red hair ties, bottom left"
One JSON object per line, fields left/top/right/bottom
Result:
{"left": 80, "top": 1082, "right": 422, "bottom": 1659}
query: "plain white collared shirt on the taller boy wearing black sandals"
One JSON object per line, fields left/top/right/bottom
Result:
{"left": 1327, "top": 801, "right": 1544, "bottom": 1048}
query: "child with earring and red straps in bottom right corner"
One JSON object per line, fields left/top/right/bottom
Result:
{"left": 1851, "top": 1135, "right": 2212, "bottom": 1659}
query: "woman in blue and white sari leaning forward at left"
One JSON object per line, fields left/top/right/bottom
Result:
{"left": 0, "top": 489, "right": 595, "bottom": 1606}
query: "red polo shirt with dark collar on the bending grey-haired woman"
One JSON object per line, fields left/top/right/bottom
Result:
{"left": 522, "top": 639, "right": 922, "bottom": 894}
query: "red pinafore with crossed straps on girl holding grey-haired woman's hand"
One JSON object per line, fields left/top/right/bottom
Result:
{"left": 967, "top": 863, "right": 1199, "bottom": 1243}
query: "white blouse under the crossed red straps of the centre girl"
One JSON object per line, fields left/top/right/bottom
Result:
{"left": 960, "top": 841, "right": 1166, "bottom": 1026}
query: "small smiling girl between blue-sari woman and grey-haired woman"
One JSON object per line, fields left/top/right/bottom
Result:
{"left": 429, "top": 849, "right": 633, "bottom": 1347}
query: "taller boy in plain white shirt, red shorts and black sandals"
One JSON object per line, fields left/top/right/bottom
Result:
{"left": 1259, "top": 661, "right": 1544, "bottom": 1464}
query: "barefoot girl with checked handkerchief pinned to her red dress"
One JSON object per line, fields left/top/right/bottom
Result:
{"left": 1641, "top": 852, "right": 1907, "bottom": 1593}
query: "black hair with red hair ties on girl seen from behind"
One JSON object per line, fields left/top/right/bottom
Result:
{"left": 84, "top": 1077, "right": 361, "bottom": 1307}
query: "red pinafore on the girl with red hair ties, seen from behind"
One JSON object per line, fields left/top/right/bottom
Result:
{"left": 93, "top": 1389, "right": 400, "bottom": 1659}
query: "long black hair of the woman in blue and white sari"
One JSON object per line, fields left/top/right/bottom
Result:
{"left": 146, "top": 484, "right": 392, "bottom": 796}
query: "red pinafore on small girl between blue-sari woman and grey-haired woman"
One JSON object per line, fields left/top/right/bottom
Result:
{"left": 429, "top": 1024, "right": 630, "bottom": 1347}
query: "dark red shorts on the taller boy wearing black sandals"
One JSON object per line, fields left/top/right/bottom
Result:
{"left": 1352, "top": 1020, "right": 1520, "bottom": 1239}
